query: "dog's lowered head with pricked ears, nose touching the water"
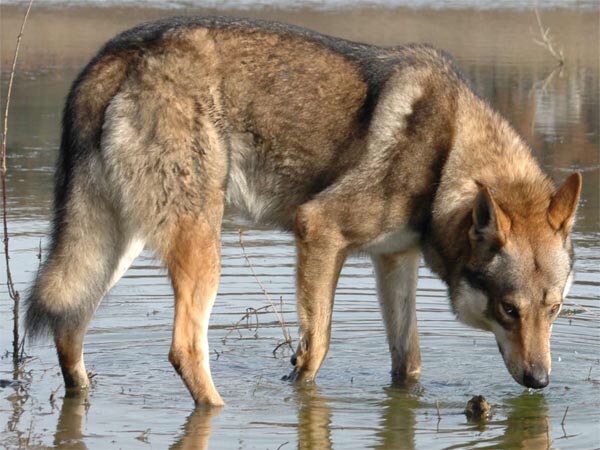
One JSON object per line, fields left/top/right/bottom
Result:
{"left": 451, "top": 174, "right": 581, "bottom": 388}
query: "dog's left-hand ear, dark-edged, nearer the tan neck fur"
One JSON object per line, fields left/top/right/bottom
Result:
{"left": 469, "top": 186, "right": 511, "bottom": 255}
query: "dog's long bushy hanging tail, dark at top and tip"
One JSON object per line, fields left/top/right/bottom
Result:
{"left": 25, "top": 53, "right": 141, "bottom": 338}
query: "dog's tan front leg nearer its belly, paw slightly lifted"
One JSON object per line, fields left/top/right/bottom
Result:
{"left": 288, "top": 205, "right": 346, "bottom": 382}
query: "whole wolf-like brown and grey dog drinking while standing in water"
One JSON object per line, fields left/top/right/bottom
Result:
{"left": 26, "top": 17, "right": 581, "bottom": 405}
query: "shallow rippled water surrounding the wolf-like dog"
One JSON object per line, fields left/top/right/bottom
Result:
{"left": 0, "top": 6, "right": 600, "bottom": 449}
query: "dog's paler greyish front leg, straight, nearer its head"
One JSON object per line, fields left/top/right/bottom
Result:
{"left": 373, "top": 249, "right": 421, "bottom": 382}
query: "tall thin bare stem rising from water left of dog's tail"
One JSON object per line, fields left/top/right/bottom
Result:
{"left": 0, "top": 0, "right": 33, "bottom": 371}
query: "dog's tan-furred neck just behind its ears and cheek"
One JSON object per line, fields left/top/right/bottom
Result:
{"left": 423, "top": 87, "right": 553, "bottom": 289}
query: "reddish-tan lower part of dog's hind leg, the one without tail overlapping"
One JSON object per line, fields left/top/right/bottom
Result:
{"left": 166, "top": 206, "right": 223, "bottom": 406}
